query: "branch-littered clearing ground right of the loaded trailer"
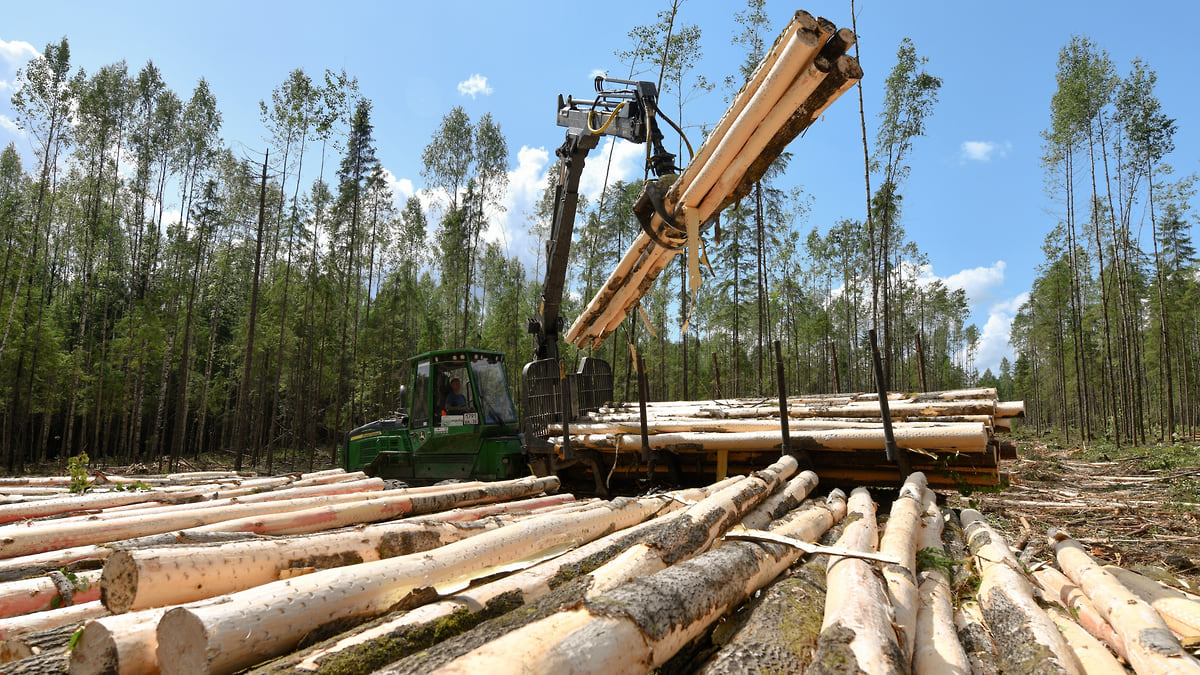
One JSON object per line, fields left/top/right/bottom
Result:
{"left": 947, "top": 441, "right": 1200, "bottom": 590}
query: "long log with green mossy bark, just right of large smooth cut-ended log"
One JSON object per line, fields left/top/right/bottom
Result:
{"left": 241, "top": 479, "right": 734, "bottom": 675}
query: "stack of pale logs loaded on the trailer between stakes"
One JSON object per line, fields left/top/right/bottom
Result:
{"left": 551, "top": 388, "right": 1025, "bottom": 488}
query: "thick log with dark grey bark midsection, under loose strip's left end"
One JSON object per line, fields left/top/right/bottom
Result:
{"left": 427, "top": 485, "right": 849, "bottom": 675}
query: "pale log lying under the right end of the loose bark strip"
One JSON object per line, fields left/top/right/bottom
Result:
{"left": 805, "top": 488, "right": 908, "bottom": 675}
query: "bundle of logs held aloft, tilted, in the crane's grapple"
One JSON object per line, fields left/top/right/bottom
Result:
{"left": 566, "top": 11, "right": 863, "bottom": 348}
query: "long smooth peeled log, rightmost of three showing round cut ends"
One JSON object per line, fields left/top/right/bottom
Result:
{"left": 158, "top": 487, "right": 696, "bottom": 674}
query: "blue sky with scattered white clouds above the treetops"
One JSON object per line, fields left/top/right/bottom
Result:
{"left": 0, "top": 0, "right": 1200, "bottom": 371}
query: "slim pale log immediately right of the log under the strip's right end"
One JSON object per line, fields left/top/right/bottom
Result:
{"left": 880, "top": 471, "right": 928, "bottom": 664}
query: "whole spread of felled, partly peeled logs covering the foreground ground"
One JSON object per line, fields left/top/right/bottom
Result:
{"left": 0, "top": 466, "right": 1200, "bottom": 674}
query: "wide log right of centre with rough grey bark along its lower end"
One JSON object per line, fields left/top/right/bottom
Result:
{"left": 961, "top": 509, "right": 1081, "bottom": 674}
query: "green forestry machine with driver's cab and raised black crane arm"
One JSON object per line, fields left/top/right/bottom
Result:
{"left": 343, "top": 77, "right": 678, "bottom": 492}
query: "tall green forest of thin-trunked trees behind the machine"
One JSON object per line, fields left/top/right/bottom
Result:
{"left": 0, "top": 0, "right": 1200, "bottom": 472}
